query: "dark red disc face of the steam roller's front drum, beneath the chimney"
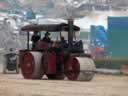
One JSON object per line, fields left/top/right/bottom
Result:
{"left": 66, "top": 58, "right": 80, "bottom": 80}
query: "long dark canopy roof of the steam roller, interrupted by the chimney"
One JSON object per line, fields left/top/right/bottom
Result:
{"left": 21, "top": 23, "right": 80, "bottom": 32}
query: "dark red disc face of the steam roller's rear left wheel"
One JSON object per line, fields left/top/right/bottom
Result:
{"left": 21, "top": 53, "right": 35, "bottom": 79}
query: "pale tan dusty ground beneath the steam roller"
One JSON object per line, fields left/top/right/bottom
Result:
{"left": 0, "top": 74, "right": 128, "bottom": 96}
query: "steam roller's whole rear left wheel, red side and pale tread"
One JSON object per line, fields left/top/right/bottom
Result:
{"left": 21, "top": 51, "right": 44, "bottom": 79}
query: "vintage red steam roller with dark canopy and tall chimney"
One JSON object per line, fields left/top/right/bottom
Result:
{"left": 19, "top": 21, "right": 95, "bottom": 81}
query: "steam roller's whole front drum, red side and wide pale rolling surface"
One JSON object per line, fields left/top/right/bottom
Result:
{"left": 65, "top": 57, "right": 95, "bottom": 81}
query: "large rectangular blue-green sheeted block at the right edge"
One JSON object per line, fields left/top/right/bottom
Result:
{"left": 107, "top": 16, "right": 128, "bottom": 57}
